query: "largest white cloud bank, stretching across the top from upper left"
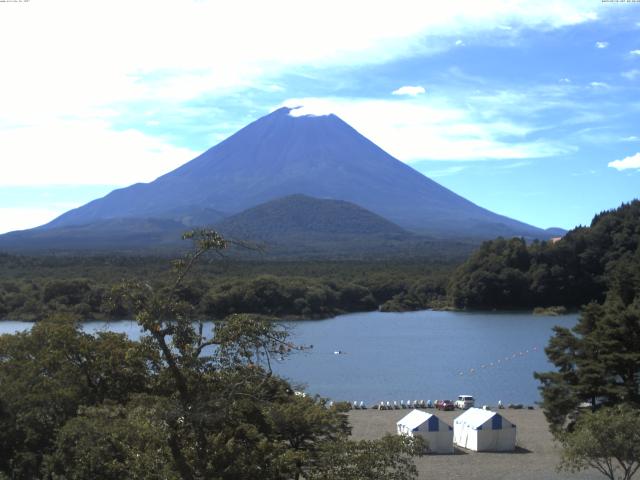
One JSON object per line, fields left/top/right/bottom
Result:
{"left": 0, "top": 0, "right": 597, "bottom": 116}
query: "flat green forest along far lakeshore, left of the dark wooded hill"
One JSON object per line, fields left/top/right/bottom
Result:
{"left": 0, "top": 255, "right": 456, "bottom": 320}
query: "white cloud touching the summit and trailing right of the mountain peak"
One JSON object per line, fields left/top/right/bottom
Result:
{"left": 285, "top": 98, "right": 571, "bottom": 162}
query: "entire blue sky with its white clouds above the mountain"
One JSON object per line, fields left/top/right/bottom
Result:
{"left": 0, "top": 0, "right": 640, "bottom": 232}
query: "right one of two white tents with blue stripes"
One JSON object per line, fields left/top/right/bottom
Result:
{"left": 453, "top": 408, "right": 516, "bottom": 452}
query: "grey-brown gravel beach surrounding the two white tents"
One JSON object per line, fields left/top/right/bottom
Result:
{"left": 349, "top": 409, "right": 608, "bottom": 480}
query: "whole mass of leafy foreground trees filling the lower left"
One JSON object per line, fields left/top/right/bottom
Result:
{"left": 0, "top": 232, "right": 425, "bottom": 480}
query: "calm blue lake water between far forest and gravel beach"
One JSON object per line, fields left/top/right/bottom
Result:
{"left": 0, "top": 311, "right": 577, "bottom": 405}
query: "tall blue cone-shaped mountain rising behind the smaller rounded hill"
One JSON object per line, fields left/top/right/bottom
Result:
{"left": 43, "top": 108, "right": 549, "bottom": 238}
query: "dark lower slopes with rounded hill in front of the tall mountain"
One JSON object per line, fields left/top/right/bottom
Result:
{"left": 0, "top": 195, "right": 477, "bottom": 260}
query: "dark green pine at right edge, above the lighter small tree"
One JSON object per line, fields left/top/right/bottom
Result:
{"left": 535, "top": 250, "right": 640, "bottom": 432}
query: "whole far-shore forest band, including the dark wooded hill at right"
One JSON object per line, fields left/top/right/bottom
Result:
{"left": 0, "top": 201, "right": 640, "bottom": 320}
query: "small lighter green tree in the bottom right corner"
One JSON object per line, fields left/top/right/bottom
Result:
{"left": 559, "top": 406, "right": 640, "bottom": 480}
